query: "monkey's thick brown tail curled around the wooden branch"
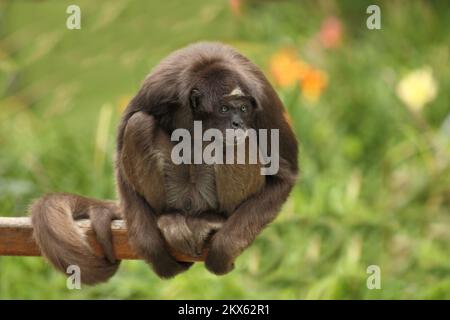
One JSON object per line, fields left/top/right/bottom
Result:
{"left": 30, "top": 193, "right": 120, "bottom": 284}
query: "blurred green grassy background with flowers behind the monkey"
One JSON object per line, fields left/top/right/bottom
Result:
{"left": 0, "top": 0, "right": 450, "bottom": 299}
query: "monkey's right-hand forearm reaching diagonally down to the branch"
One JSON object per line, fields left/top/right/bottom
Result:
{"left": 205, "top": 159, "right": 296, "bottom": 274}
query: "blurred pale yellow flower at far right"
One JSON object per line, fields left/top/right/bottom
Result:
{"left": 396, "top": 67, "right": 437, "bottom": 111}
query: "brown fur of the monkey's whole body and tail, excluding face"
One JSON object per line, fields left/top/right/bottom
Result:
{"left": 31, "top": 43, "right": 298, "bottom": 283}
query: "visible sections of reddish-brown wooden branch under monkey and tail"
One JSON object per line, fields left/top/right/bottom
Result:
{"left": 0, "top": 217, "right": 207, "bottom": 262}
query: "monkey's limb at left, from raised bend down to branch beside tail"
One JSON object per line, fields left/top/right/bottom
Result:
{"left": 117, "top": 112, "right": 192, "bottom": 278}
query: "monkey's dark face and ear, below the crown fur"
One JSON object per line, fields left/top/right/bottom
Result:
{"left": 191, "top": 89, "right": 256, "bottom": 142}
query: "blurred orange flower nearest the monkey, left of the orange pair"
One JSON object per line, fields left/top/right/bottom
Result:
{"left": 270, "top": 49, "right": 309, "bottom": 87}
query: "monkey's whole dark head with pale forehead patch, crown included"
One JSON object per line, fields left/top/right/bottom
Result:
{"left": 189, "top": 69, "right": 258, "bottom": 144}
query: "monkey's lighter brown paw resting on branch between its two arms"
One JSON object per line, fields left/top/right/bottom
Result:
{"left": 157, "top": 212, "right": 225, "bottom": 257}
